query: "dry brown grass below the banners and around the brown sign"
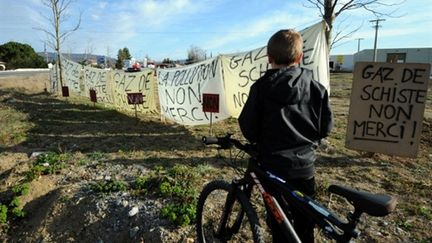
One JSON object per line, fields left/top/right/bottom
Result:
{"left": 0, "top": 74, "right": 432, "bottom": 242}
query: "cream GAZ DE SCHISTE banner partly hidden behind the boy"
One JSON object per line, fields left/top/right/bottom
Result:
{"left": 221, "top": 22, "right": 330, "bottom": 118}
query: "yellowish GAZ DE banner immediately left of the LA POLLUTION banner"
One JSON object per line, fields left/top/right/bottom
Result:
{"left": 112, "top": 69, "right": 157, "bottom": 113}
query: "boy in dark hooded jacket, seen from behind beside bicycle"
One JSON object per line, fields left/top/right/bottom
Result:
{"left": 239, "top": 29, "right": 333, "bottom": 242}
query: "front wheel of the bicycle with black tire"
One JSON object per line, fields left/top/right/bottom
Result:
{"left": 196, "top": 180, "right": 264, "bottom": 243}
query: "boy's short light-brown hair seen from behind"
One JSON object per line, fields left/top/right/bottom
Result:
{"left": 267, "top": 29, "right": 303, "bottom": 65}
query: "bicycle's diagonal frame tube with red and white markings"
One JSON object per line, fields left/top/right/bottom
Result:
{"left": 250, "top": 172, "right": 301, "bottom": 243}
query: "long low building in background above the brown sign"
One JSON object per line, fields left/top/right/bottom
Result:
{"left": 329, "top": 48, "right": 432, "bottom": 72}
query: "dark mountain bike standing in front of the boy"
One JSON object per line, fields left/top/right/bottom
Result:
{"left": 196, "top": 134, "right": 397, "bottom": 243}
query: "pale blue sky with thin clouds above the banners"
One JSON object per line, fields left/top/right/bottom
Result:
{"left": 0, "top": 0, "right": 432, "bottom": 61}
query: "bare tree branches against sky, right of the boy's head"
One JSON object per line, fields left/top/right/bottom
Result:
{"left": 305, "top": 0, "right": 403, "bottom": 51}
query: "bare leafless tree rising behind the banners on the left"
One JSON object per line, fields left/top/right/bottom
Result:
{"left": 35, "top": 0, "right": 82, "bottom": 86}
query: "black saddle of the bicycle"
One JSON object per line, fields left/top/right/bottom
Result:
{"left": 328, "top": 185, "right": 397, "bottom": 217}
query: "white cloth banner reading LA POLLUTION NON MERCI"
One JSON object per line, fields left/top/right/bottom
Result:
{"left": 157, "top": 58, "right": 229, "bottom": 125}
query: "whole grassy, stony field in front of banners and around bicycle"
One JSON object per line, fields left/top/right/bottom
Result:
{"left": 0, "top": 74, "right": 432, "bottom": 242}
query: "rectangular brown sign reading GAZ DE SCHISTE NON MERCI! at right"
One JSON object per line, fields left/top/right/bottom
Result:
{"left": 346, "top": 62, "right": 430, "bottom": 157}
